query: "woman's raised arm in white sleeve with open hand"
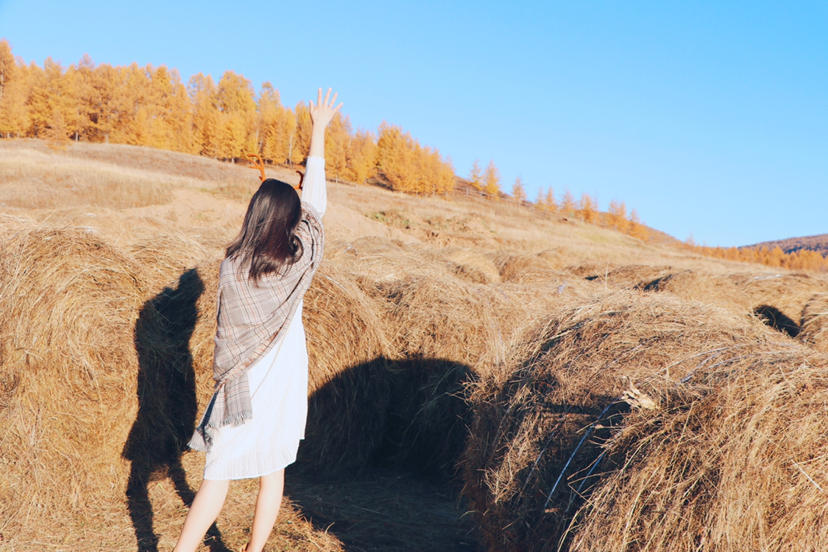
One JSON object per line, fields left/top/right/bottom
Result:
{"left": 302, "top": 88, "right": 342, "bottom": 216}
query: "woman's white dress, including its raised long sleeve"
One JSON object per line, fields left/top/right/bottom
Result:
{"left": 204, "top": 157, "right": 327, "bottom": 480}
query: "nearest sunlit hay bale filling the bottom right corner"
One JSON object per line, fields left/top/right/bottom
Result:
{"left": 569, "top": 354, "right": 828, "bottom": 552}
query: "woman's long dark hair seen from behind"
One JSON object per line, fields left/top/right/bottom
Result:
{"left": 227, "top": 178, "right": 302, "bottom": 282}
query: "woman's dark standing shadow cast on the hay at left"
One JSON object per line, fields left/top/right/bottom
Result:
{"left": 123, "top": 269, "right": 228, "bottom": 552}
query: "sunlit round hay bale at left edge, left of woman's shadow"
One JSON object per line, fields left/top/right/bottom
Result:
{"left": 0, "top": 227, "right": 146, "bottom": 542}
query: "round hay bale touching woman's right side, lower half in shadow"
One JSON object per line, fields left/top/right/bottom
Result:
{"left": 296, "top": 261, "right": 391, "bottom": 473}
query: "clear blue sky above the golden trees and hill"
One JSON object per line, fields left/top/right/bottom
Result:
{"left": 0, "top": 0, "right": 828, "bottom": 246}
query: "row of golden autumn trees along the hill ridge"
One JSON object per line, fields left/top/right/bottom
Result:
{"left": 0, "top": 40, "right": 828, "bottom": 271}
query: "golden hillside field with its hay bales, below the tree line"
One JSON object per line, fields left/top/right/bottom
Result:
{"left": 0, "top": 140, "right": 828, "bottom": 552}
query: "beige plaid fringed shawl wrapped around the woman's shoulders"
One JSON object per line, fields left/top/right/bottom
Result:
{"left": 189, "top": 202, "right": 325, "bottom": 451}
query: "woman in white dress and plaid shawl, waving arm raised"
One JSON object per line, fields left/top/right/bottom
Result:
{"left": 175, "top": 88, "right": 342, "bottom": 552}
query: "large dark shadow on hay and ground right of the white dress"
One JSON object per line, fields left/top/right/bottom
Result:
{"left": 286, "top": 357, "right": 479, "bottom": 552}
